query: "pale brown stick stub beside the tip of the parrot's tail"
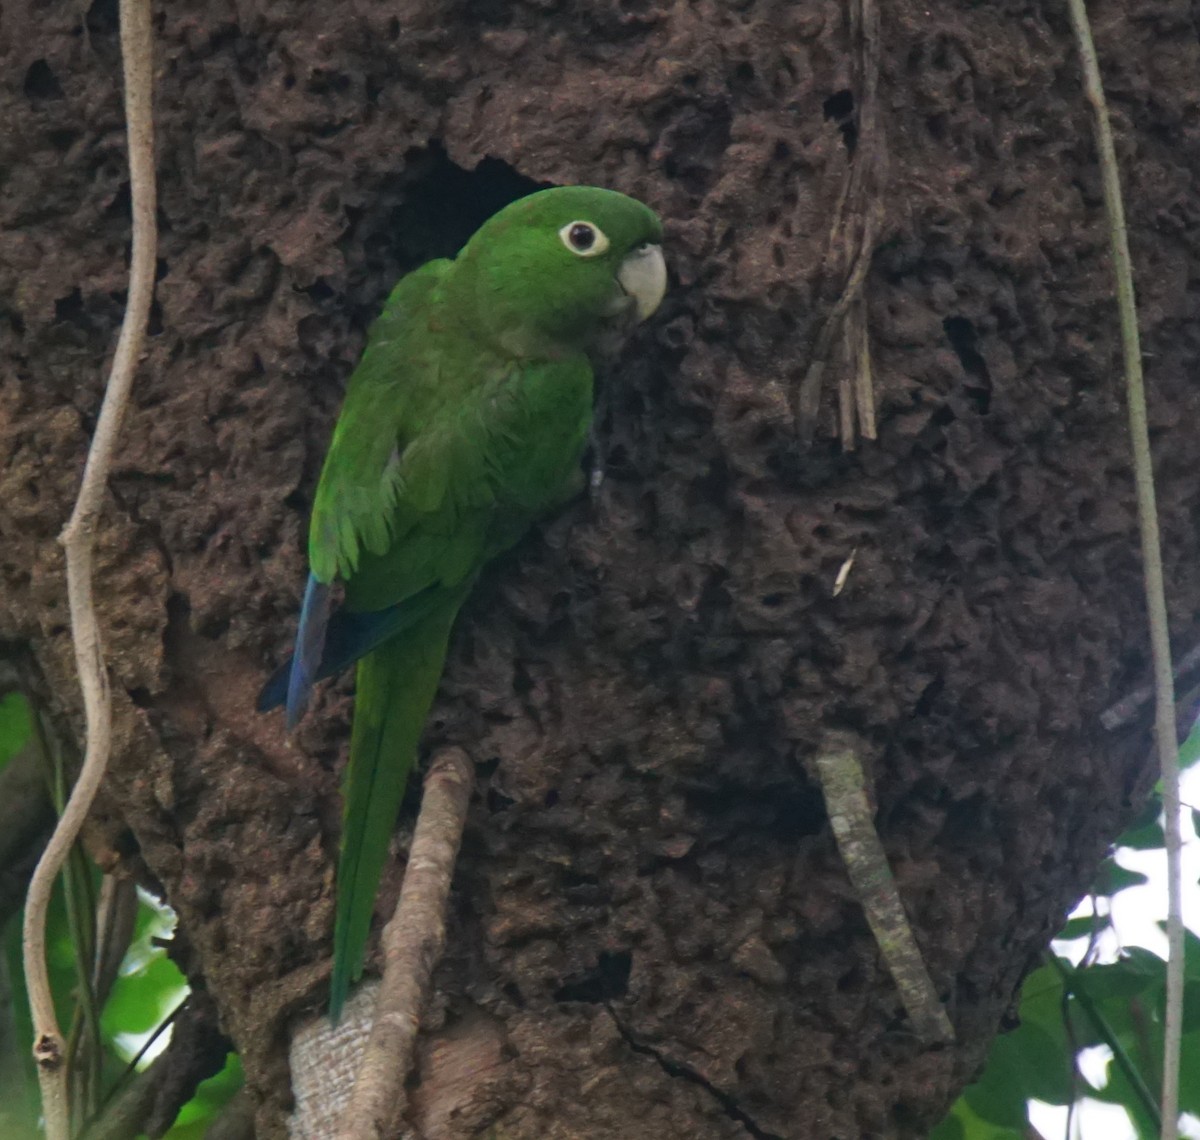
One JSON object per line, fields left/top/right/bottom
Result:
{"left": 337, "top": 749, "right": 474, "bottom": 1140}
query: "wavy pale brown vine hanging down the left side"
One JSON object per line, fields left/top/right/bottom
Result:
{"left": 23, "top": 0, "right": 157, "bottom": 1140}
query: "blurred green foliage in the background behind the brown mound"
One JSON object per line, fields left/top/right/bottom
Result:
{"left": 0, "top": 692, "right": 1200, "bottom": 1140}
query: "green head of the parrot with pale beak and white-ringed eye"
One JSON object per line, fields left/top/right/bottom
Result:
{"left": 455, "top": 186, "right": 667, "bottom": 356}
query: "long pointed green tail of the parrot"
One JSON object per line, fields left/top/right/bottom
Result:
{"left": 329, "top": 596, "right": 461, "bottom": 1022}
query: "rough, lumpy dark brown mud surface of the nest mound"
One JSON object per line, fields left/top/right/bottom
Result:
{"left": 0, "top": 0, "right": 1200, "bottom": 1140}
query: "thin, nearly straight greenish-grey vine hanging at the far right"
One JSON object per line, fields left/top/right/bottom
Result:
{"left": 1068, "top": 8, "right": 1183, "bottom": 1140}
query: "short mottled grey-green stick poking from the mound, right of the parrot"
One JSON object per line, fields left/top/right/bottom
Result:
{"left": 816, "top": 733, "right": 954, "bottom": 1042}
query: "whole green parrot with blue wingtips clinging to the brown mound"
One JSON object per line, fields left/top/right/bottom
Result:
{"left": 258, "top": 186, "right": 666, "bottom": 1022}
